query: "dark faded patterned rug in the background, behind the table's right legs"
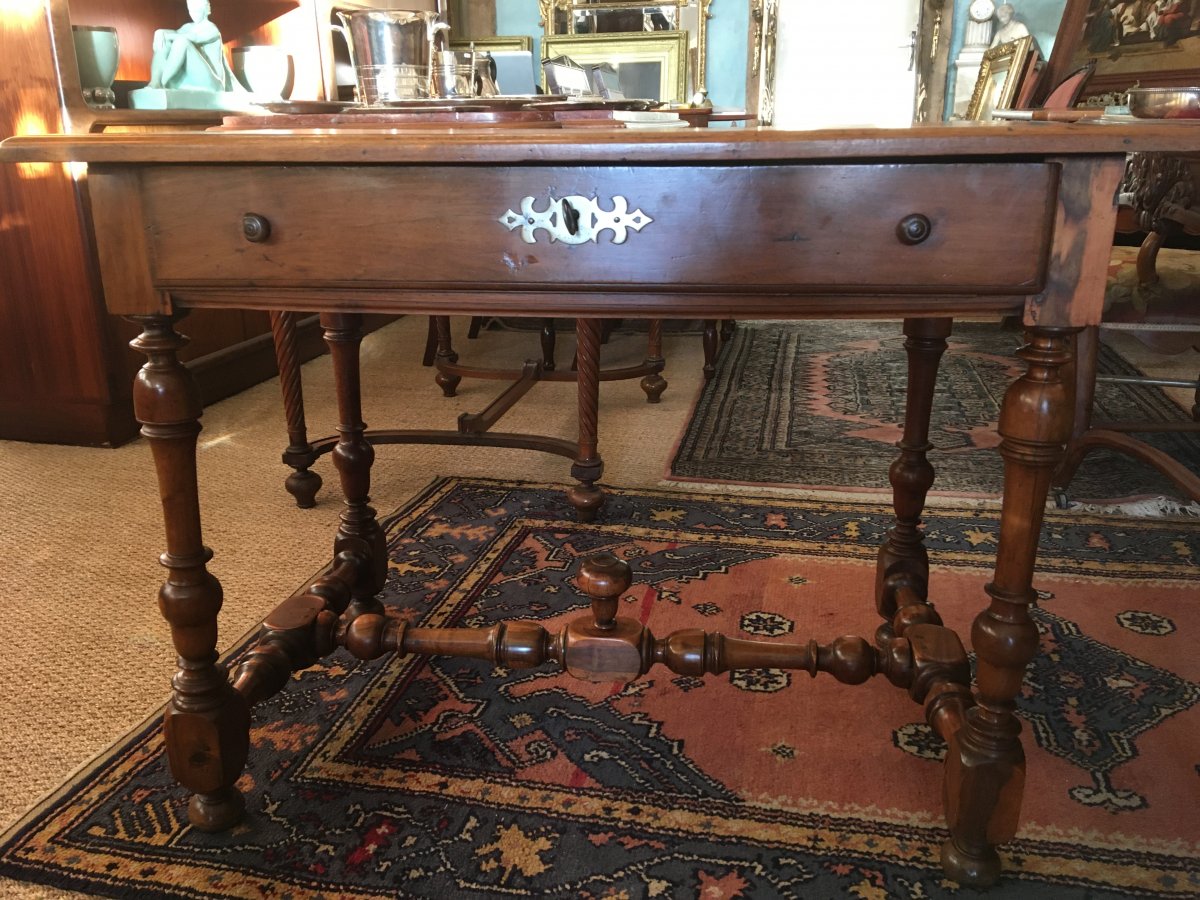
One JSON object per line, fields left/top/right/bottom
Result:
{"left": 668, "top": 322, "right": 1200, "bottom": 502}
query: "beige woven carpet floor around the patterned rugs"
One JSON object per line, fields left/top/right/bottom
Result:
{"left": 0, "top": 317, "right": 1194, "bottom": 898}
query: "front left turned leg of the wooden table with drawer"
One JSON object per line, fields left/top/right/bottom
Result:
{"left": 131, "top": 316, "right": 250, "bottom": 832}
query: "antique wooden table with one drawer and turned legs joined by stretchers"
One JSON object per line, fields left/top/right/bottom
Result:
{"left": 0, "top": 124, "right": 1196, "bottom": 884}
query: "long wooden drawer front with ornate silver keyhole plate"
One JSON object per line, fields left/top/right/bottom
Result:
{"left": 143, "top": 163, "right": 1056, "bottom": 294}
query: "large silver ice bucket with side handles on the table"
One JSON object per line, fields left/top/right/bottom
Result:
{"left": 334, "top": 10, "right": 450, "bottom": 107}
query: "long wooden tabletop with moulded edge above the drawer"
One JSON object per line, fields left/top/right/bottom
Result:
{"left": 7, "top": 120, "right": 1200, "bottom": 164}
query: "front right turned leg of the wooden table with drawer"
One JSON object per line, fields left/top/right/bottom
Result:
{"left": 942, "top": 328, "right": 1076, "bottom": 886}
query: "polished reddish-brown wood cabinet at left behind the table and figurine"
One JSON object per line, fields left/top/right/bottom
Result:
{"left": 0, "top": 0, "right": 332, "bottom": 445}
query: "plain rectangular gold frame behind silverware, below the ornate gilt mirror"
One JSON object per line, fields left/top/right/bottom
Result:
{"left": 541, "top": 31, "right": 688, "bottom": 103}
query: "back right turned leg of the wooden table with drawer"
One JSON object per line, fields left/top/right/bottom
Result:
{"left": 875, "top": 318, "right": 953, "bottom": 647}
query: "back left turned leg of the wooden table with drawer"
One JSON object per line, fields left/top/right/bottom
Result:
{"left": 320, "top": 313, "right": 388, "bottom": 617}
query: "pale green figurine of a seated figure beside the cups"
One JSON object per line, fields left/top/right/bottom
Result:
{"left": 130, "top": 0, "right": 248, "bottom": 109}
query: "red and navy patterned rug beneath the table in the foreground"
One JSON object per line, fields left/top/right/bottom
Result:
{"left": 0, "top": 479, "right": 1200, "bottom": 900}
